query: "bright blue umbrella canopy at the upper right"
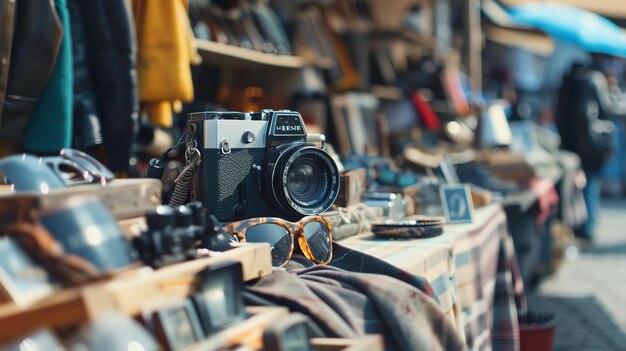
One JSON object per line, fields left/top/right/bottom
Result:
{"left": 509, "top": 2, "right": 626, "bottom": 57}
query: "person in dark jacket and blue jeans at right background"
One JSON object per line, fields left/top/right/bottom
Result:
{"left": 555, "top": 54, "right": 626, "bottom": 244}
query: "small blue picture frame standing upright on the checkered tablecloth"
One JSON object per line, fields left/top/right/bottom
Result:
{"left": 439, "top": 184, "right": 474, "bottom": 223}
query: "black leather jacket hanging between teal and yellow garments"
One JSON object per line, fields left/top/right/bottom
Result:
{"left": 77, "top": 0, "right": 139, "bottom": 172}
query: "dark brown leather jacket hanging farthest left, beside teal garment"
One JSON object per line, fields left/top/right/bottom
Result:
{"left": 0, "top": 0, "right": 63, "bottom": 149}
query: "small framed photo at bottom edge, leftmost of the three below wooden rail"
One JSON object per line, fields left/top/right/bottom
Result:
{"left": 151, "top": 300, "right": 204, "bottom": 351}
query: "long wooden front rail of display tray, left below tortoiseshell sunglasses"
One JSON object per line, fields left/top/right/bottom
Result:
{"left": 0, "top": 243, "right": 272, "bottom": 345}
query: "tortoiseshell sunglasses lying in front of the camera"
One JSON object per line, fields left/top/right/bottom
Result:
{"left": 224, "top": 216, "right": 332, "bottom": 267}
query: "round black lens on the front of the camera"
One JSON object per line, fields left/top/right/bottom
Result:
{"left": 264, "top": 143, "right": 339, "bottom": 218}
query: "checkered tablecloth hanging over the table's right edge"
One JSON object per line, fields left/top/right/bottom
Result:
{"left": 341, "top": 204, "right": 524, "bottom": 350}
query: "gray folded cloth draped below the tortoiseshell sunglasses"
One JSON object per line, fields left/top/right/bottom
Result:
{"left": 244, "top": 265, "right": 465, "bottom": 350}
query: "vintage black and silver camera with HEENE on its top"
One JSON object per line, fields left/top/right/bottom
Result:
{"left": 187, "top": 110, "right": 339, "bottom": 221}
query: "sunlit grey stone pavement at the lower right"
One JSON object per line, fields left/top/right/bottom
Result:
{"left": 529, "top": 200, "right": 626, "bottom": 351}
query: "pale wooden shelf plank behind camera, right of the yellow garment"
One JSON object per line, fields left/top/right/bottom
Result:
{"left": 196, "top": 39, "right": 307, "bottom": 69}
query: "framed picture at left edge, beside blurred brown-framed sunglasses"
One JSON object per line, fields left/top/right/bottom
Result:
{"left": 0, "top": 237, "right": 55, "bottom": 306}
